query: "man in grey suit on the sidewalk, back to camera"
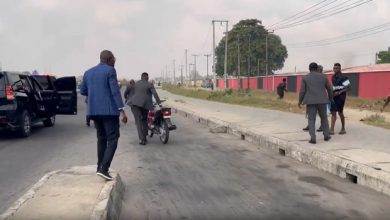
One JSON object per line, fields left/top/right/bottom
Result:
{"left": 298, "top": 63, "right": 333, "bottom": 144}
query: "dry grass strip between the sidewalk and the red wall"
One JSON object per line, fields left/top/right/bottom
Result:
{"left": 163, "top": 85, "right": 390, "bottom": 129}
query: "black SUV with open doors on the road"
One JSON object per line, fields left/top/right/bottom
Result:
{"left": 0, "top": 71, "right": 77, "bottom": 137}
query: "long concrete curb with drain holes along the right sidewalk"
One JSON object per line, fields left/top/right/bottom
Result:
{"left": 171, "top": 106, "right": 390, "bottom": 196}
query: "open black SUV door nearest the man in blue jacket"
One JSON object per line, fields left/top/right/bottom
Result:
{"left": 54, "top": 76, "right": 77, "bottom": 115}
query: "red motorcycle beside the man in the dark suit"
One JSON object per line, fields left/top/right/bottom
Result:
{"left": 147, "top": 100, "right": 176, "bottom": 144}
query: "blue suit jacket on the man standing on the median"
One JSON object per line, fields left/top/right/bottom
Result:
{"left": 80, "top": 63, "right": 124, "bottom": 116}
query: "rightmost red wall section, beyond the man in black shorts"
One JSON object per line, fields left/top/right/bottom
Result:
{"left": 359, "top": 72, "right": 390, "bottom": 98}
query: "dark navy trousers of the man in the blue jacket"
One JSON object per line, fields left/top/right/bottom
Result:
{"left": 92, "top": 116, "right": 120, "bottom": 171}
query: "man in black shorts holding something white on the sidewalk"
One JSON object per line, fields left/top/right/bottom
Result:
{"left": 330, "top": 63, "right": 351, "bottom": 135}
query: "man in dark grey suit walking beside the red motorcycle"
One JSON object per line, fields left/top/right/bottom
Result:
{"left": 127, "top": 73, "right": 161, "bottom": 145}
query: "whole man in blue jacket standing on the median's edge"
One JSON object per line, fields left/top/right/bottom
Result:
{"left": 80, "top": 50, "right": 127, "bottom": 180}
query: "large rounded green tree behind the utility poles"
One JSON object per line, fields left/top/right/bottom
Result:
{"left": 215, "top": 19, "right": 287, "bottom": 76}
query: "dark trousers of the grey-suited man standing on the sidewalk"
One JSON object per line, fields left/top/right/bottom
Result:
{"left": 306, "top": 104, "right": 329, "bottom": 140}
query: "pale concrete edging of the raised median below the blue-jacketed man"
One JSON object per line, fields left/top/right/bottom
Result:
{"left": 0, "top": 166, "right": 124, "bottom": 220}
